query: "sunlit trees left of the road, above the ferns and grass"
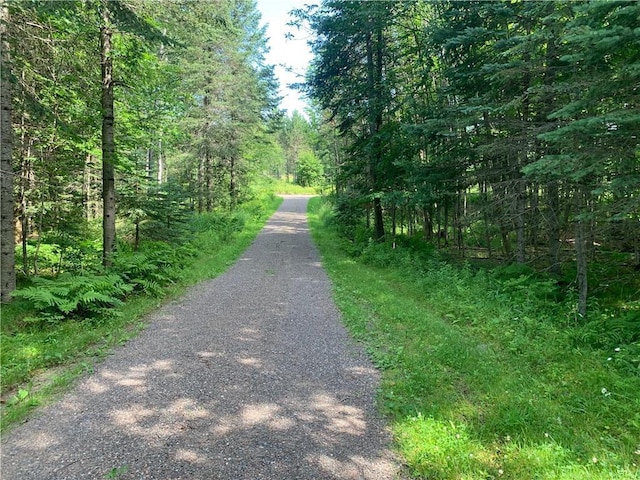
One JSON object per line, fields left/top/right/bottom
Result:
{"left": 0, "top": 0, "right": 328, "bottom": 301}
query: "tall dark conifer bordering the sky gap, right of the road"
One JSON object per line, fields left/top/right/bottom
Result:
{"left": 307, "top": 1, "right": 394, "bottom": 240}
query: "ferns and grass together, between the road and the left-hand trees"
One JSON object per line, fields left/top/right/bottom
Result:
{"left": 0, "top": 194, "right": 281, "bottom": 430}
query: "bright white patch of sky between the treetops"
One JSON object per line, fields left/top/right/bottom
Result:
{"left": 257, "top": 0, "right": 313, "bottom": 114}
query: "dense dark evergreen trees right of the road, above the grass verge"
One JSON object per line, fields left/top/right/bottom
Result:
{"left": 298, "top": 0, "right": 640, "bottom": 316}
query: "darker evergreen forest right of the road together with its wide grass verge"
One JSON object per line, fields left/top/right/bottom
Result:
{"left": 296, "top": 1, "right": 640, "bottom": 479}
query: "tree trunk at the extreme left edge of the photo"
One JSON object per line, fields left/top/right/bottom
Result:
{"left": 0, "top": 4, "right": 16, "bottom": 303}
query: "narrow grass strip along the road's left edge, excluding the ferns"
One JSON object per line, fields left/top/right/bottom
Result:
{"left": 0, "top": 195, "right": 282, "bottom": 431}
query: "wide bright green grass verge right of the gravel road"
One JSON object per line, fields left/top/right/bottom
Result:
{"left": 310, "top": 198, "right": 640, "bottom": 480}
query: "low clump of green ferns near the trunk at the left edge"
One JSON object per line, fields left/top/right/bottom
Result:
{"left": 13, "top": 274, "right": 133, "bottom": 322}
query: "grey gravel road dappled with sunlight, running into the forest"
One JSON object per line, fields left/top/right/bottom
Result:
{"left": 0, "top": 196, "right": 400, "bottom": 480}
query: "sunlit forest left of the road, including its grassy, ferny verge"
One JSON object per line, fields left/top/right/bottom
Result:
{"left": 0, "top": 0, "right": 326, "bottom": 428}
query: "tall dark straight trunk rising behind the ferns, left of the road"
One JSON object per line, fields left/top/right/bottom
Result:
{"left": 100, "top": 1, "right": 116, "bottom": 267}
